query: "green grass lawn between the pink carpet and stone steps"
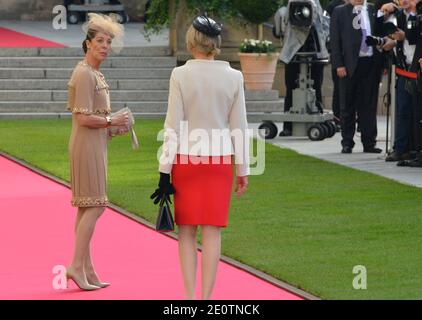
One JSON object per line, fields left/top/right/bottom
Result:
{"left": 0, "top": 120, "right": 422, "bottom": 299}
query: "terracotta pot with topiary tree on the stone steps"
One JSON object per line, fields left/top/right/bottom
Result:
{"left": 234, "top": 0, "right": 280, "bottom": 90}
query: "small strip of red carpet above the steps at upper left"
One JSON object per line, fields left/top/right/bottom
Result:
{"left": 0, "top": 27, "right": 66, "bottom": 48}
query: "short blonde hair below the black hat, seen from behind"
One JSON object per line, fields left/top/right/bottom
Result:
{"left": 186, "top": 25, "right": 221, "bottom": 56}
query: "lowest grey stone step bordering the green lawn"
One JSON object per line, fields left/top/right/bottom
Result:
{"left": 0, "top": 99, "right": 283, "bottom": 114}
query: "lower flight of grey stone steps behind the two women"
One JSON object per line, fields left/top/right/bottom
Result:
{"left": 0, "top": 47, "right": 282, "bottom": 121}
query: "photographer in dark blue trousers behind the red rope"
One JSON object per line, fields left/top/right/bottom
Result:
{"left": 380, "top": 0, "right": 416, "bottom": 162}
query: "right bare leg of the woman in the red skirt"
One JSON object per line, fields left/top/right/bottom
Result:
{"left": 202, "top": 226, "right": 221, "bottom": 300}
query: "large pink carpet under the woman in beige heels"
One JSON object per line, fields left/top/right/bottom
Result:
{"left": 0, "top": 156, "right": 300, "bottom": 300}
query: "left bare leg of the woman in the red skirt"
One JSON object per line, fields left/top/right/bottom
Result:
{"left": 179, "top": 225, "right": 197, "bottom": 300}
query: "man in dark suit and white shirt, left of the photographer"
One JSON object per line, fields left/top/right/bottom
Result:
{"left": 330, "top": 0, "right": 395, "bottom": 153}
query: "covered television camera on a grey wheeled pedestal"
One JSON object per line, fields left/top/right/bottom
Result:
{"left": 259, "top": 0, "right": 336, "bottom": 141}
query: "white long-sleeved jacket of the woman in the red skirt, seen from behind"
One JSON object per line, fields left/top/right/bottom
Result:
{"left": 159, "top": 59, "right": 250, "bottom": 176}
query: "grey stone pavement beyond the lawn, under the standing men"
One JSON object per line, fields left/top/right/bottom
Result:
{"left": 250, "top": 116, "right": 422, "bottom": 188}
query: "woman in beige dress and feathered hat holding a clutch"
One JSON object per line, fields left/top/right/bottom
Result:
{"left": 66, "top": 14, "right": 129, "bottom": 290}
